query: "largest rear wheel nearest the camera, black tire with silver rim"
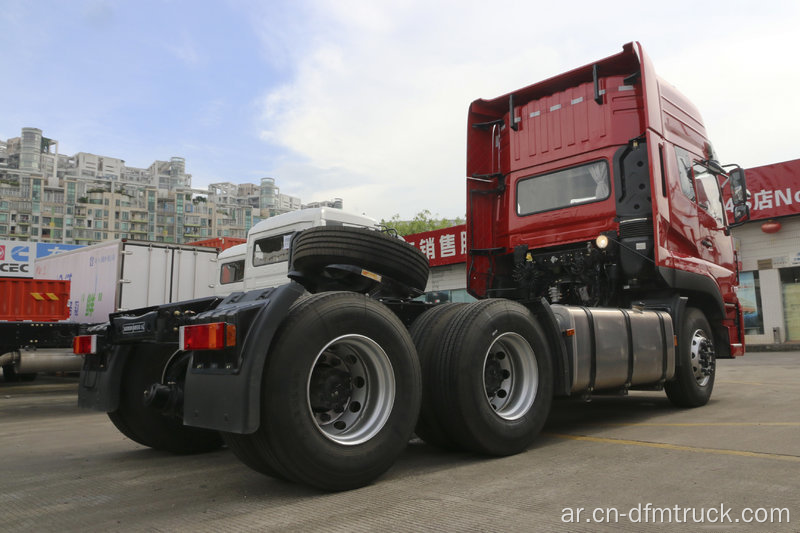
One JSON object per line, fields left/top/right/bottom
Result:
{"left": 244, "top": 292, "right": 421, "bottom": 491}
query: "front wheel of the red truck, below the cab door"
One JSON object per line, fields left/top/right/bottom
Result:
{"left": 664, "top": 307, "right": 717, "bottom": 407}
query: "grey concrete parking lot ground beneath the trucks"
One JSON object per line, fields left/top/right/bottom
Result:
{"left": 0, "top": 352, "right": 800, "bottom": 532}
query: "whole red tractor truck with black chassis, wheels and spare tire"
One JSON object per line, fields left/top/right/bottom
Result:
{"left": 75, "top": 43, "right": 748, "bottom": 490}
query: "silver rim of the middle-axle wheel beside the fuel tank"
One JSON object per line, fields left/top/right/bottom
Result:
{"left": 483, "top": 332, "right": 539, "bottom": 420}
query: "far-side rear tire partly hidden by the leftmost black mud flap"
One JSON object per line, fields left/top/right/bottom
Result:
{"left": 108, "top": 347, "right": 222, "bottom": 454}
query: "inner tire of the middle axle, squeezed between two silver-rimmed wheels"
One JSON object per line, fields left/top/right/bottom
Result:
{"left": 409, "top": 303, "right": 467, "bottom": 449}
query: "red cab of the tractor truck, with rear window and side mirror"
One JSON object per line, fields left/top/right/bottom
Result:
{"left": 467, "top": 43, "right": 747, "bottom": 357}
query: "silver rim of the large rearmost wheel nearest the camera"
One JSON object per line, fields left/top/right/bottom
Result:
{"left": 306, "top": 334, "right": 395, "bottom": 446}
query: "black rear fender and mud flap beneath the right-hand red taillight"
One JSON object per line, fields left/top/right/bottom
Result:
{"left": 183, "top": 282, "right": 305, "bottom": 433}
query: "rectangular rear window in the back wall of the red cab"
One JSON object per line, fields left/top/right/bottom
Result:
{"left": 517, "top": 161, "right": 611, "bottom": 216}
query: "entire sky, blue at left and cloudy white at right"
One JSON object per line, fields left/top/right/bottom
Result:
{"left": 0, "top": 0, "right": 800, "bottom": 218}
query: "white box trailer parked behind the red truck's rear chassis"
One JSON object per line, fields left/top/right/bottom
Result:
{"left": 34, "top": 239, "right": 217, "bottom": 323}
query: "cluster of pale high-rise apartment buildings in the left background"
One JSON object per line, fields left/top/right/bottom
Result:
{"left": 0, "top": 128, "right": 252, "bottom": 244}
